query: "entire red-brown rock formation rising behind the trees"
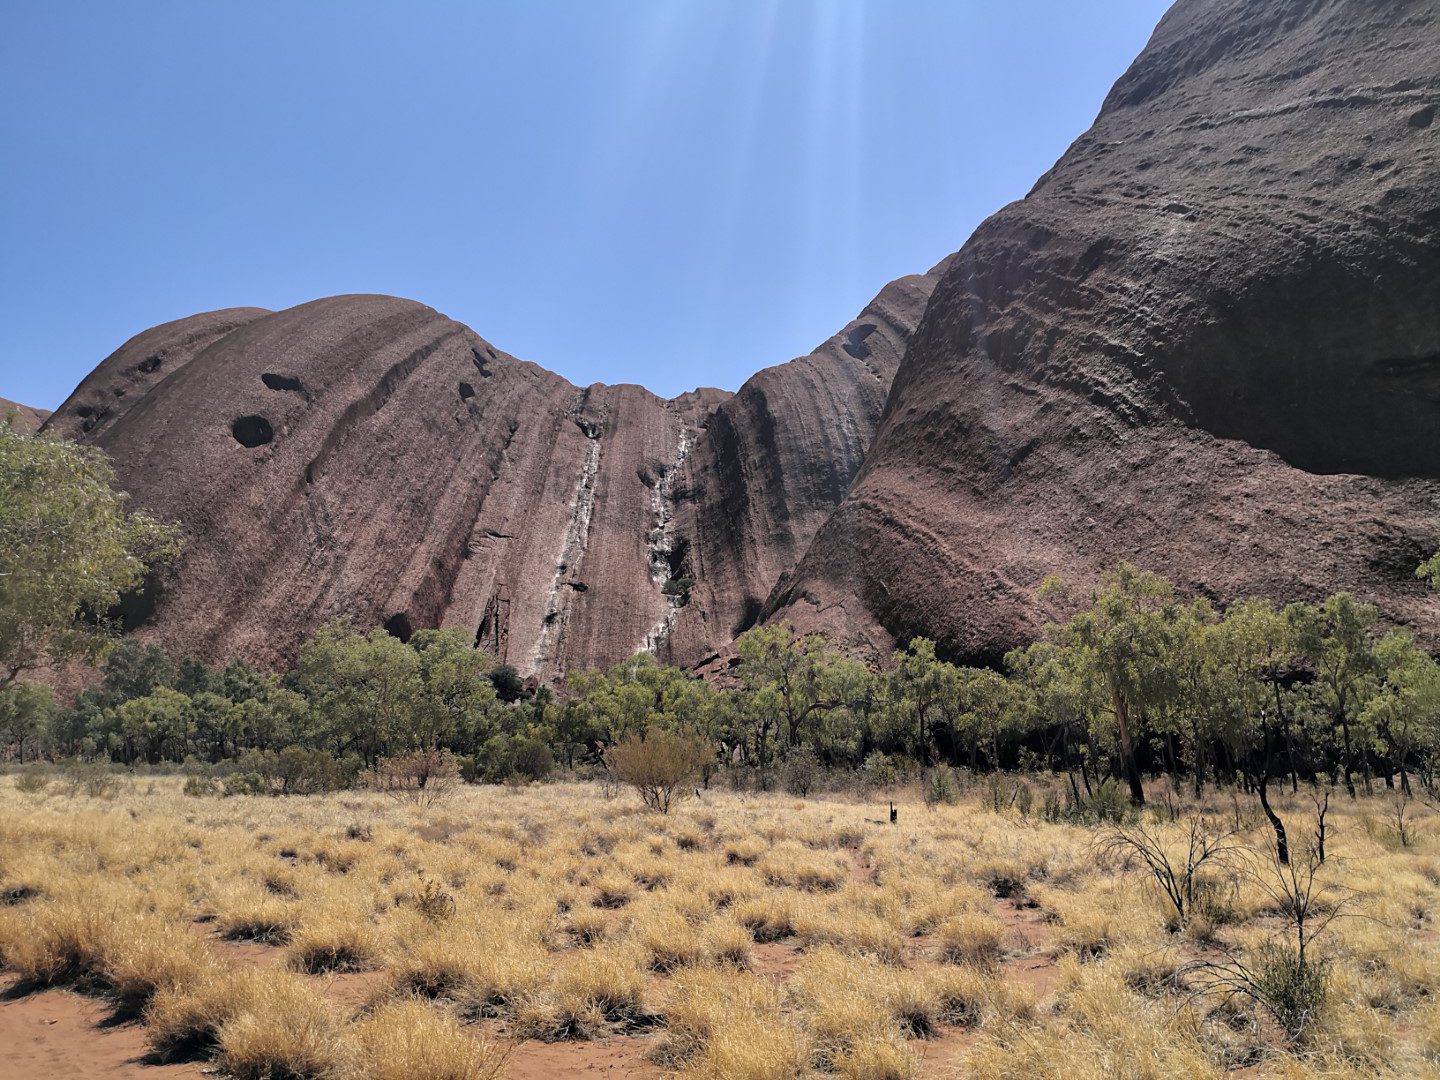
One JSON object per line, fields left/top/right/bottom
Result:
{"left": 46, "top": 0, "right": 1440, "bottom": 677}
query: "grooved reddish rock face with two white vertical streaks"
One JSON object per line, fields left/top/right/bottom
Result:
{"left": 46, "top": 267, "right": 937, "bottom": 678}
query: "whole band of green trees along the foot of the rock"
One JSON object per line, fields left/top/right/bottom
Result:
{"left": 0, "top": 423, "right": 1440, "bottom": 804}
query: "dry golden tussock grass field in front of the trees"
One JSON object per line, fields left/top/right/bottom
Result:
{"left": 0, "top": 778, "right": 1440, "bottom": 1080}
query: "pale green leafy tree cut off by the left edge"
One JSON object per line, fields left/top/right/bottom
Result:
{"left": 0, "top": 425, "right": 179, "bottom": 687}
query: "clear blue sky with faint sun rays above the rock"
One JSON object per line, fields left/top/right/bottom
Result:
{"left": 0, "top": 0, "right": 1166, "bottom": 408}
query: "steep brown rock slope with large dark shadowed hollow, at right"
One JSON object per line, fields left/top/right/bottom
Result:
{"left": 768, "top": 0, "right": 1440, "bottom": 661}
